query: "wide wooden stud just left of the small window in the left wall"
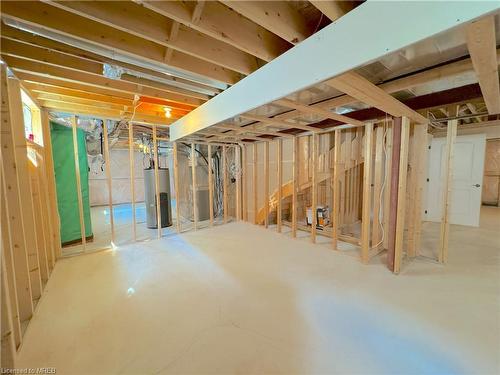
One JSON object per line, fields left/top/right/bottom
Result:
{"left": 0, "top": 64, "right": 33, "bottom": 322}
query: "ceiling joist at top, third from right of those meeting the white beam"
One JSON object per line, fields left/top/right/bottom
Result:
{"left": 138, "top": 0, "right": 292, "bottom": 61}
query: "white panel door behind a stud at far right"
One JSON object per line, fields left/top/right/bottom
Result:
{"left": 424, "top": 134, "right": 486, "bottom": 227}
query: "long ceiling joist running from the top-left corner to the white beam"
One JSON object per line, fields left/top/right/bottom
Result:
{"left": 2, "top": 1, "right": 241, "bottom": 84}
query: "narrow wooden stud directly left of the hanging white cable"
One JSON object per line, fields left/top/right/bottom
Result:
{"left": 372, "top": 126, "right": 384, "bottom": 247}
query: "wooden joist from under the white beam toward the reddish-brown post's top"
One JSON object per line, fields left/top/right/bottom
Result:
{"left": 326, "top": 72, "right": 427, "bottom": 124}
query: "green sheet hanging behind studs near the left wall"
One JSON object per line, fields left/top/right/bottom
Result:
{"left": 50, "top": 122, "right": 92, "bottom": 244}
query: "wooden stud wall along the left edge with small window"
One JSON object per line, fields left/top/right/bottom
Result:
{"left": 0, "top": 65, "right": 61, "bottom": 367}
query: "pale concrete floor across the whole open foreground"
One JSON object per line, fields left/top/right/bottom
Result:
{"left": 17, "top": 207, "right": 500, "bottom": 375}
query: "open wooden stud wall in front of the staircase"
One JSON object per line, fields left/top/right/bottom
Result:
{"left": 243, "top": 114, "right": 436, "bottom": 273}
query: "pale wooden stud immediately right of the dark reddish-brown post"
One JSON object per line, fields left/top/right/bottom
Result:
{"left": 413, "top": 124, "right": 428, "bottom": 256}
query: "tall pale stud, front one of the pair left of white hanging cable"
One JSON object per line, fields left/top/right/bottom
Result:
{"left": 361, "top": 123, "right": 373, "bottom": 263}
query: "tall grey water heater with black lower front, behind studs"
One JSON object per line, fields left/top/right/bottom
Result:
{"left": 144, "top": 168, "right": 172, "bottom": 228}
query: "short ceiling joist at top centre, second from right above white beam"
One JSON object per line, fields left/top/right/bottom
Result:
{"left": 222, "top": 1, "right": 314, "bottom": 44}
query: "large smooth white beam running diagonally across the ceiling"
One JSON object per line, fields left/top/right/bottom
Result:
{"left": 170, "top": 1, "right": 497, "bottom": 140}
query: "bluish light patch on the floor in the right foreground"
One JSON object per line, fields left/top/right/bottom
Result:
{"left": 303, "top": 290, "right": 470, "bottom": 375}
